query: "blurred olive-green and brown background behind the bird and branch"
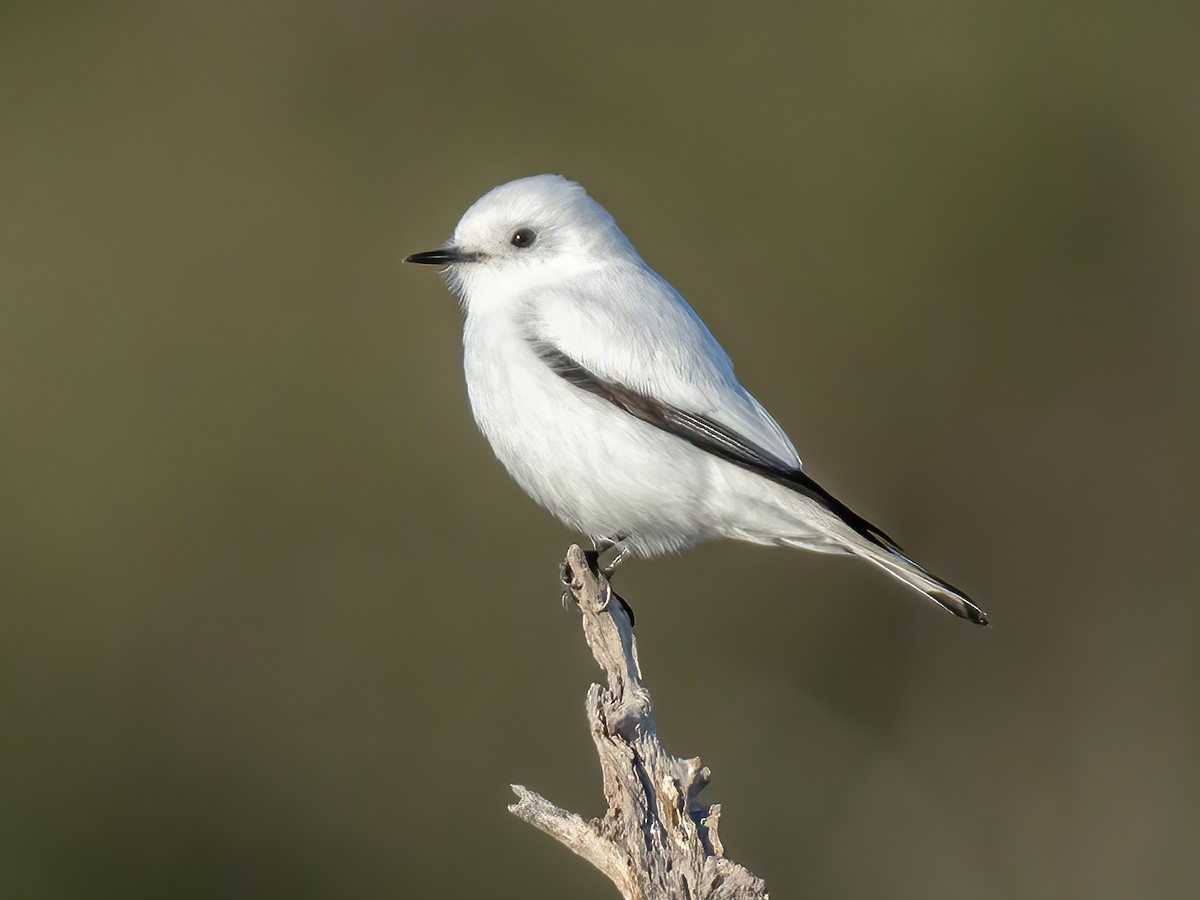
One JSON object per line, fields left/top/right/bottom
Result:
{"left": 0, "top": 0, "right": 1200, "bottom": 900}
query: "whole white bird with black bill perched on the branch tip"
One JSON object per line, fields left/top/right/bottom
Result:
{"left": 406, "top": 175, "right": 988, "bottom": 625}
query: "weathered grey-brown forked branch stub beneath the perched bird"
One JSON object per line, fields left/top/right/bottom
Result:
{"left": 509, "top": 546, "right": 767, "bottom": 900}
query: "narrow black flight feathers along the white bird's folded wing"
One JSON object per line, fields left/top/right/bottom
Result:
{"left": 530, "top": 340, "right": 902, "bottom": 556}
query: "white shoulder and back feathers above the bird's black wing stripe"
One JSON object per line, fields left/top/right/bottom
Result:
{"left": 527, "top": 265, "right": 800, "bottom": 469}
